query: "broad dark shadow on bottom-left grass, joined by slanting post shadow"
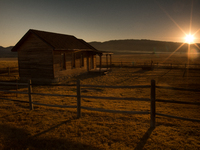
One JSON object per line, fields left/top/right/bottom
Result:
{"left": 0, "top": 120, "right": 103, "bottom": 150}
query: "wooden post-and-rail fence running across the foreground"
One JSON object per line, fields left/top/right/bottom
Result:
{"left": 0, "top": 80, "right": 200, "bottom": 127}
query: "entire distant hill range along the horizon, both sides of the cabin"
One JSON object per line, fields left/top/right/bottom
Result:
{"left": 0, "top": 39, "right": 200, "bottom": 57}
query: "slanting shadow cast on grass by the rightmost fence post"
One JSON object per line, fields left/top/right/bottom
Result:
{"left": 134, "top": 128, "right": 155, "bottom": 150}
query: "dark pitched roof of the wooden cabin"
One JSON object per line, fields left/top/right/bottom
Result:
{"left": 11, "top": 29, "right": 100, "bottom": 52}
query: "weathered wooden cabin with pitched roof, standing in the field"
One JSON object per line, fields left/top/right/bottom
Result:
{"left": 11, "top": 29, "right": 111, "bottom": 82}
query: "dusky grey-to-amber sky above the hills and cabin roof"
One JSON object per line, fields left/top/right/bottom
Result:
{"left": 0, "top": 0, "right": 200, "bottom": 47}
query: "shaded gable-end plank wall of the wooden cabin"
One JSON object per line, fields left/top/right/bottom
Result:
{"left": 18, "top": 34, "right": 54, "bottom": 80}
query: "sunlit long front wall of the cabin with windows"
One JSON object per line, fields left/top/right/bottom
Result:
{"left": 53, "top": 51, "right": 96, "bottom": 80}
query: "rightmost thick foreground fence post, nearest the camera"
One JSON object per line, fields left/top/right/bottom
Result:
{"left": 150, "top": 80, "right": 156, "bottom": 128}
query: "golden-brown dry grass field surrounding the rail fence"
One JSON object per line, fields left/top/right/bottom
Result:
{"left": 0, "top": 54, "right": 200, "bottom": 150}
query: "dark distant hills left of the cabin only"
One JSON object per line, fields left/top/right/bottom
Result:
{"left": 0, "top": 46, "right": 17, "bottom": 58}
